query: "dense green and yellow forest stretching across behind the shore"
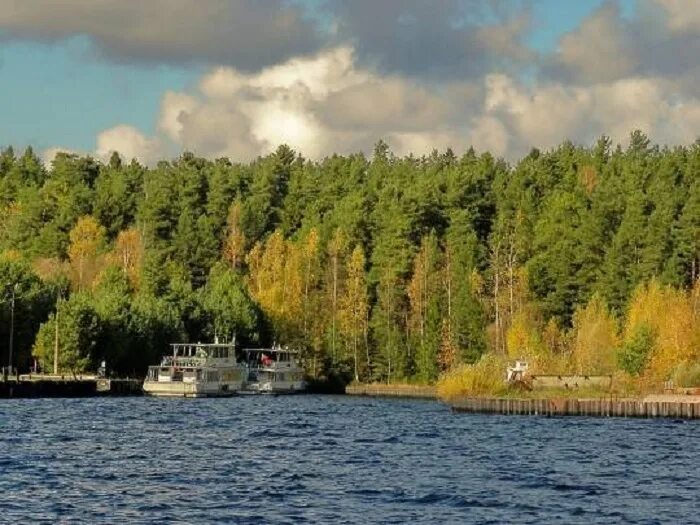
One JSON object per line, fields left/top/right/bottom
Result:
{"left": 0, "top": 131, "right": 700, "bottom": 384}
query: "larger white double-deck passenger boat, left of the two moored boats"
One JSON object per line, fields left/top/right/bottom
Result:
{"left": 143, "top": 343, "right": 247, "bottom": 397}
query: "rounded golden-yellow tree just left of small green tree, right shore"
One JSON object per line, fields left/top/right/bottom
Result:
{"left": 571, "top": 294, "right": 620, "bottom": 375}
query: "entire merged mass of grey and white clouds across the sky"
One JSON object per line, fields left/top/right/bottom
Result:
{"left": 13, "top": 0, "right": 700, "bottom": 163}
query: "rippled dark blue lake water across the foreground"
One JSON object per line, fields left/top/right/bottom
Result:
{"left": 0, "top": 396, "right": 700, "bottom": 524}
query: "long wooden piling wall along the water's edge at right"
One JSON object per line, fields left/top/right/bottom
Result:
{"left": 448, "top": 395, "right": 700, "bottom": 419}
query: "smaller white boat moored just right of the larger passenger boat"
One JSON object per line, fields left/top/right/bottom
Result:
{"left": 242, "top": 345, "right": 306, "bottom": 394}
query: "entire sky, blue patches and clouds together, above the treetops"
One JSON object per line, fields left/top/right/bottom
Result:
{"left": 0, "top": 0, "right": 700, "bottom": 162}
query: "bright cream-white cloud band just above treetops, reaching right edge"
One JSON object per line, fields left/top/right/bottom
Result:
{"left": 86, "top": 47, "right": 700, "bottom": 165}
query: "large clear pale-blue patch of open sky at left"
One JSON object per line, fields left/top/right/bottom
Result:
{"left": 0, "top": 37, "right": 202, "bottom": 151}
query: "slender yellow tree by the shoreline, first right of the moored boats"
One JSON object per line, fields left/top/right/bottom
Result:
{"left": 339, "top": 245, "right": 370, "bottom": 381}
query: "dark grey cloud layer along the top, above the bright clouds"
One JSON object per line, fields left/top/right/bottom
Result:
{"left": 0, "top": 0, "right": 534, "bottom": 78}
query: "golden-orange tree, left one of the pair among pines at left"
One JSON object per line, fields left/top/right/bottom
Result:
{"left": 68, "top": 215, "right": 105, "bottom": 290}
